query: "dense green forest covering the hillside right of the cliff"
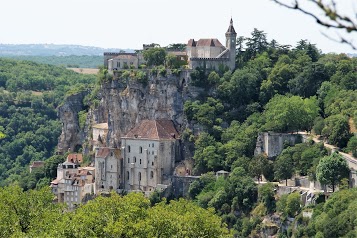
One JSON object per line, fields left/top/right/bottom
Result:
{"left": 184, "top": 29, "right": 357, "bottom": 234}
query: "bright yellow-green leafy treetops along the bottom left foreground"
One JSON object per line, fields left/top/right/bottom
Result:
{"left": 0, "top": 186, "right": 230, "bottom": 237}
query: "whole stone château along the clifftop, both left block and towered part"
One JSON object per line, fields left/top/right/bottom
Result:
{"left": 104, "top": 19, "right": 237, "bottom": 71}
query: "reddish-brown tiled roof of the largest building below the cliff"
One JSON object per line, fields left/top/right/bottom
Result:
{"left": 125, "top": 120, "right": 179, "bottom": 140}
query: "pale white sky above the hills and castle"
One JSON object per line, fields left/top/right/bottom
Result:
{"left": 0, "top": 0, "right": 357, "bottom": 53}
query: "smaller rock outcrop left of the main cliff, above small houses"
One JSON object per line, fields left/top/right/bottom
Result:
{"left": 58, "top": 91, "right": 88, "bottom": 153}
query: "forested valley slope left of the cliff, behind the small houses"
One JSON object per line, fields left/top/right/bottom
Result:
{"left": 0, "top": 59, "right": 95, "bottom": 189}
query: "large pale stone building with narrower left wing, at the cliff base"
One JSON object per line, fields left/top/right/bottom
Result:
{"left": 95, "top": 119, "right": 181, "bottom": 194}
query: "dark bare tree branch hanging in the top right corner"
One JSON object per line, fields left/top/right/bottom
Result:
{"left": 272, "top": 0, "right": 357, "bottom": 50}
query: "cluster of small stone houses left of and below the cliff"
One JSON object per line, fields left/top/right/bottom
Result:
{"left": 51, "top": 161, "right": 95, "bottom": 209}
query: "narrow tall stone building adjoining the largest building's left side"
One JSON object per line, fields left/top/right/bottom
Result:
{"left": 94, "top": 147, "right": 123, "bottom": 193}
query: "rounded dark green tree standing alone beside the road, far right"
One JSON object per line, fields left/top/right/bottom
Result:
{"left": 316, "top": 153, "right": 350, "bottom": 192}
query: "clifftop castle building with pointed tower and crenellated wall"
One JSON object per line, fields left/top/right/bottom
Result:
{"left": 186, "top": 19, "right": 237, "bottom": 70}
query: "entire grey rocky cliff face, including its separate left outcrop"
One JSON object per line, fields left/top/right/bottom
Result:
{"left": 58, "top": 71, "right": 202, "bottom": 152}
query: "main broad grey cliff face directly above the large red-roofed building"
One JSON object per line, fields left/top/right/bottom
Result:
{"left": 101, "top": 71, "right": 195, "bottom": 147}
